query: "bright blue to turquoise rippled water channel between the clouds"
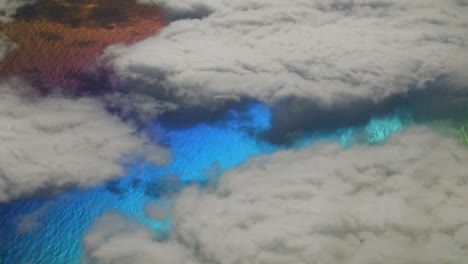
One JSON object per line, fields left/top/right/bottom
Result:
{"left": 0, "top": 103, "right": 412, "bottom": 264}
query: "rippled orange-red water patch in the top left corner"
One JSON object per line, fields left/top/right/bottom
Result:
{"left": 0, "top": 0, "right": 165, "bottom": 93}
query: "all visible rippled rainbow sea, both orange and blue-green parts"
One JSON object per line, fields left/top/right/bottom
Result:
{"left": 0, "top": 0, "right": 468, "bottom": 264}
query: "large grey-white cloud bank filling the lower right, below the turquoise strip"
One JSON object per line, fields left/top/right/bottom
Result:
{"left": 84, "top": 127, "right": 468, "bottom": 264}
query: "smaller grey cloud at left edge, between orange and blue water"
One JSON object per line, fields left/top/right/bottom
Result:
{"left": 0, "top": 83, "right": 168, "bottom": 202}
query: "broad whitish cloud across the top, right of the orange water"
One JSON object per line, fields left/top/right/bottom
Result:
{"left": 109, "top": 0, "right": 468, "bottom": 105}
